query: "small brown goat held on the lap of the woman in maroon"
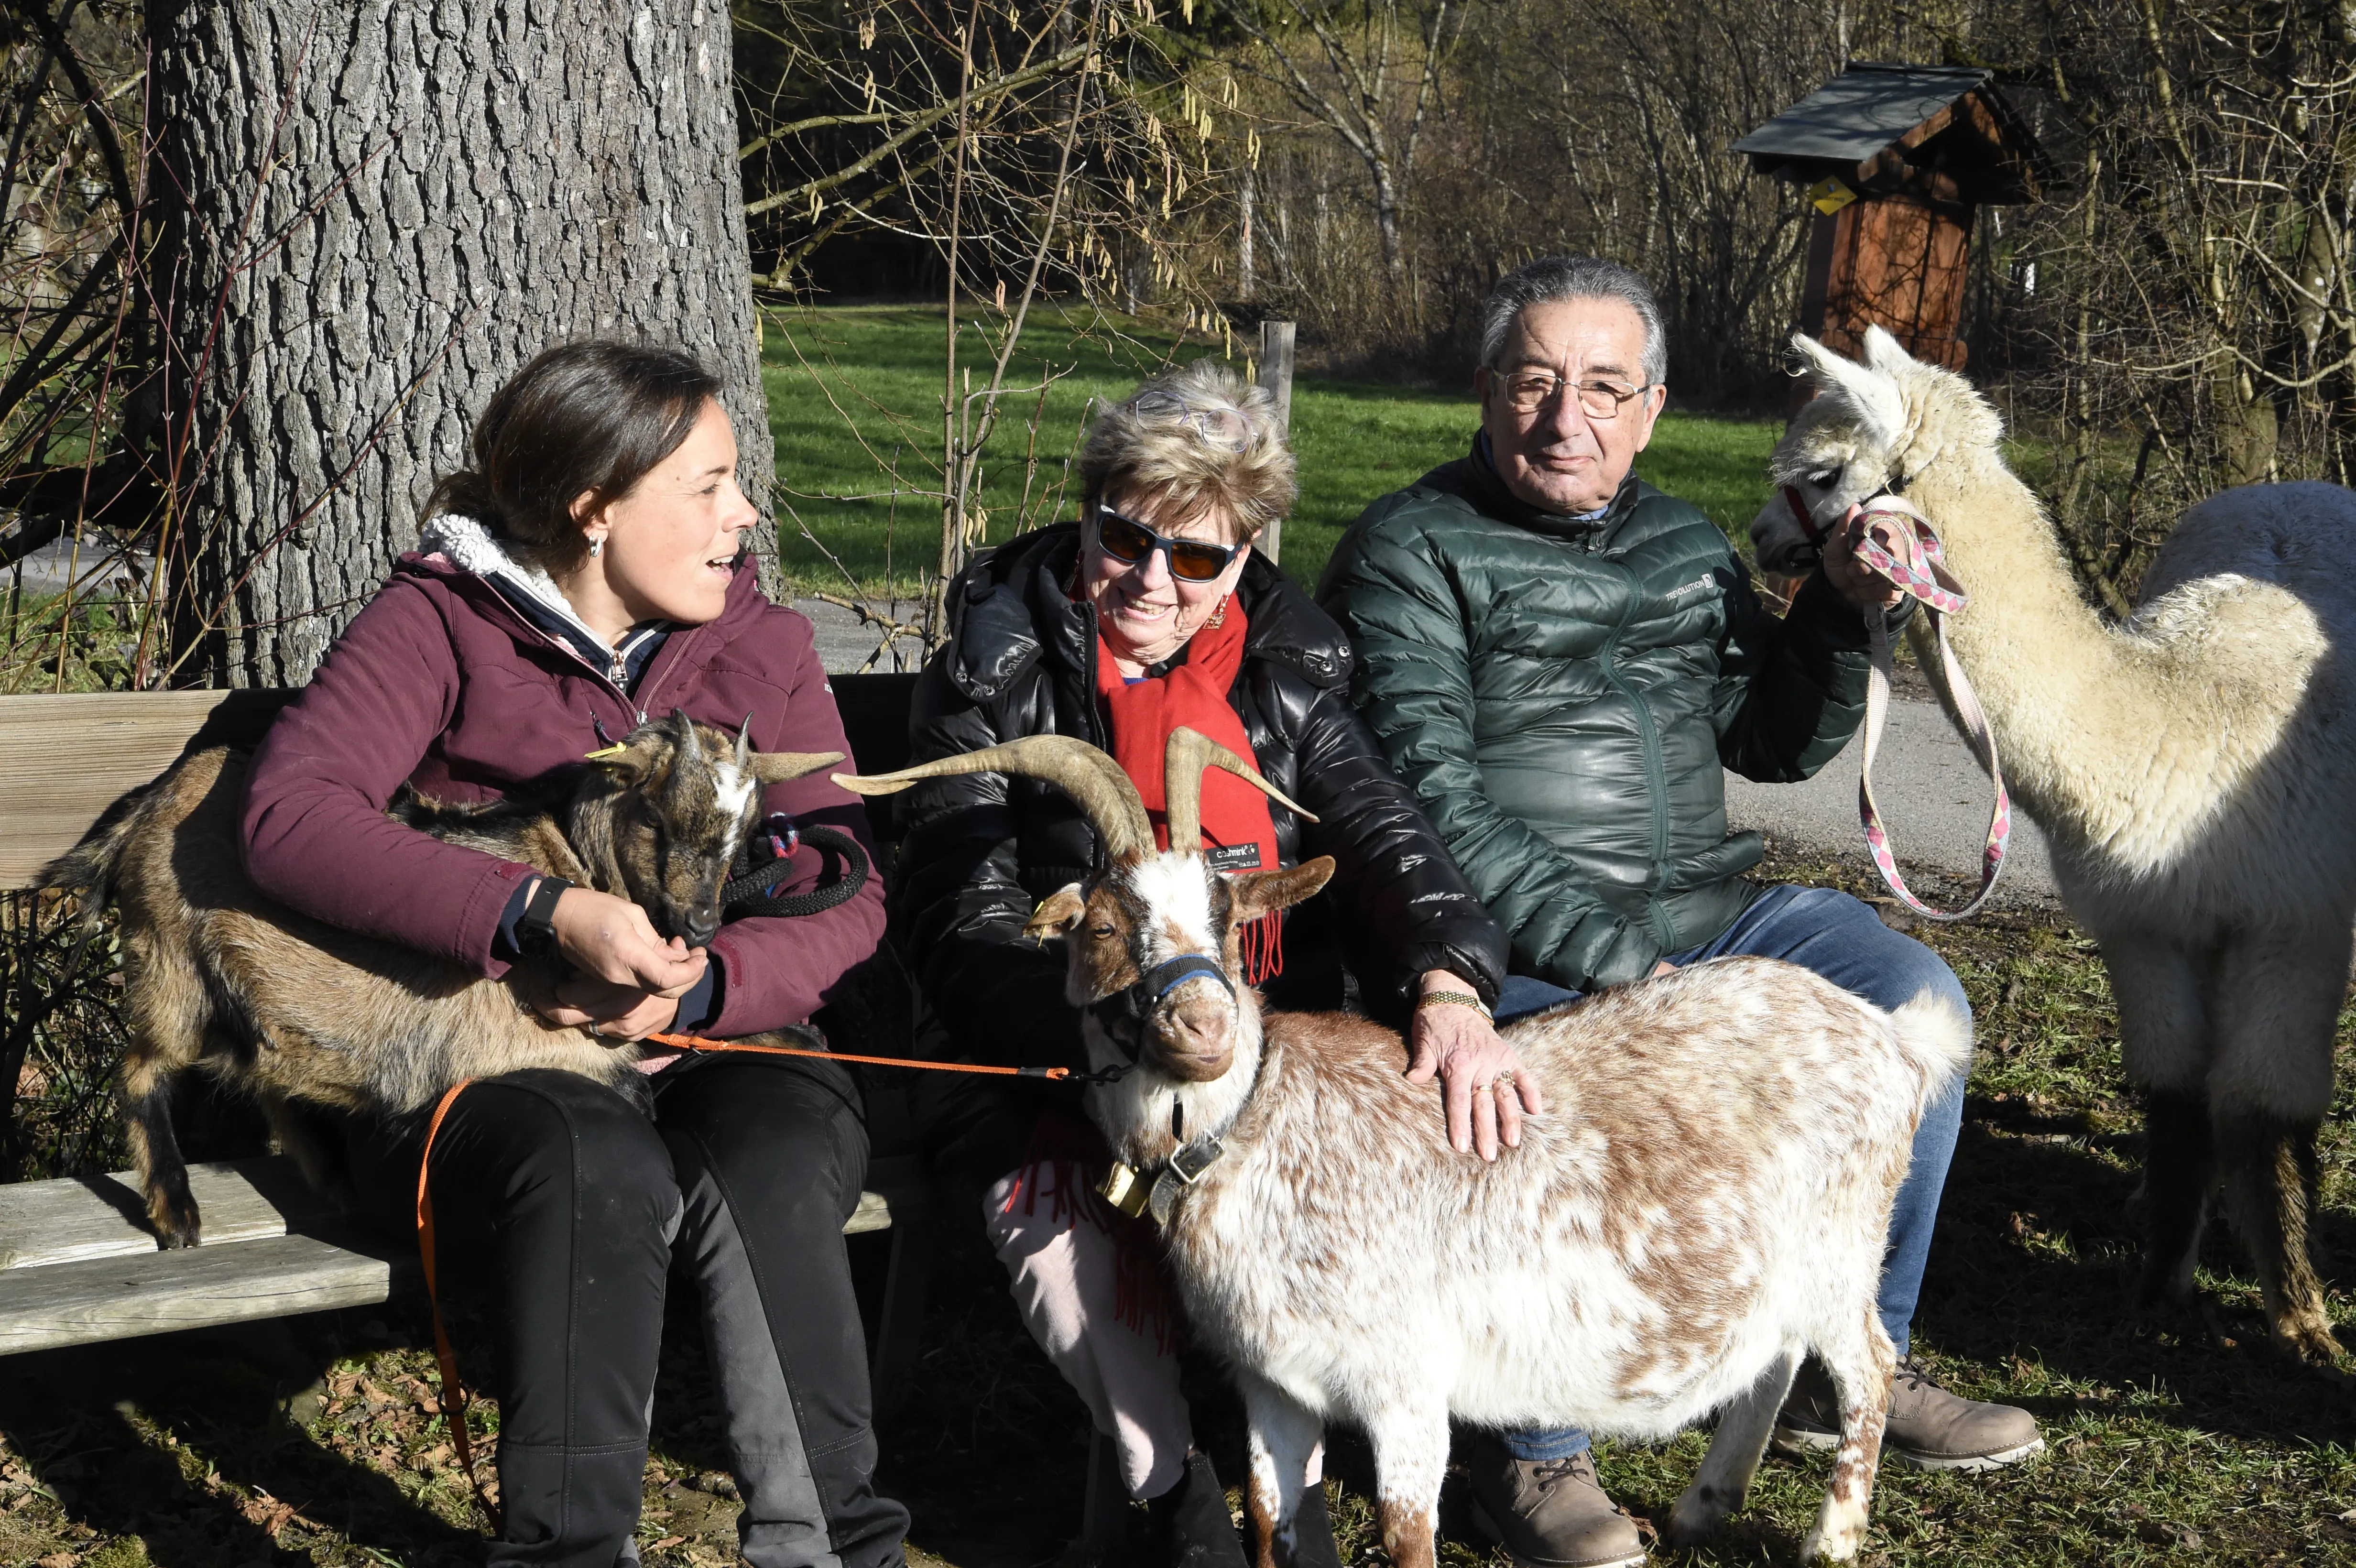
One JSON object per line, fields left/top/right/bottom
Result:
{"left": 43, "top": 713, "right": 841, "bottom": 1248}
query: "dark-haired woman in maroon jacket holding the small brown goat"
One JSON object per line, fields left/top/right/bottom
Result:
{"left": 243, "top": 344, "right": 907, "bottom": 1568}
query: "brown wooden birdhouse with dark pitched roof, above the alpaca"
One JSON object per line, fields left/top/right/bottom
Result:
{"left": 1734, "top": 61, "right": 2047, "bottom": 370}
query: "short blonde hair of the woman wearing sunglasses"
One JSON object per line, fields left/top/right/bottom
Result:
{"left": 1079, "top": 360, "right": 1298, "bottom": 544}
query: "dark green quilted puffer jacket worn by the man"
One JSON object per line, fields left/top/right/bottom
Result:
{"left": 1317, "top": 440, "right": 1868, "bottom": 991}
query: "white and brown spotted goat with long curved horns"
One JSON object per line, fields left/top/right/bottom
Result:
{"left": 836, "top": 730, "right": 1970, "bottom": 1568}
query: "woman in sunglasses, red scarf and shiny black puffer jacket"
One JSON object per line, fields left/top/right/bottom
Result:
{"left": 893, "top": 360, "right": 1507, "bottom": 1568}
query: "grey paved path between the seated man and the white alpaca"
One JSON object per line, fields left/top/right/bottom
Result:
{"left": 1727, "top": 699, "right": 2062, "bottom": 904}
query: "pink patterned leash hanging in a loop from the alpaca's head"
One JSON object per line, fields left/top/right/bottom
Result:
{"left": 1819, "top": 494, "right": 2012, "bottom": 921}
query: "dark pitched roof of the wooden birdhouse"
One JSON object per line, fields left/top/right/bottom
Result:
{"left": 1734, "top": 61, "right": 2045, "bottom": 203}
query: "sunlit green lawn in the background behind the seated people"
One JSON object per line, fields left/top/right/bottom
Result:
{"left": 761, "top": 306, "right": 1781, "bottom": 593}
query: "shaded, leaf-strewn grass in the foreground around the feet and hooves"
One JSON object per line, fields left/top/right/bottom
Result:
{"left": 0, "top": 860, "right": 2356, "bottom": 1568}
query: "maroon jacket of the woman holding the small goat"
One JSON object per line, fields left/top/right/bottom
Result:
{"left": 243, "top": 544, "right": 884, "bottom": 1036}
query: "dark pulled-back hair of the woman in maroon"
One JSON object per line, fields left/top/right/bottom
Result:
{"left": 426, "top": 341, "right": 721, "bottom": 572}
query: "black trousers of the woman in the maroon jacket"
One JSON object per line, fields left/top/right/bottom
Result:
{"left": 346, "top": 1057, "right": 907, "bottom": 1568}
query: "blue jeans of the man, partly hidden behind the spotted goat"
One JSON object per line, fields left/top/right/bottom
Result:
{"left": 1496, "top": 888, "right": 1972, "bottom": 1459}
